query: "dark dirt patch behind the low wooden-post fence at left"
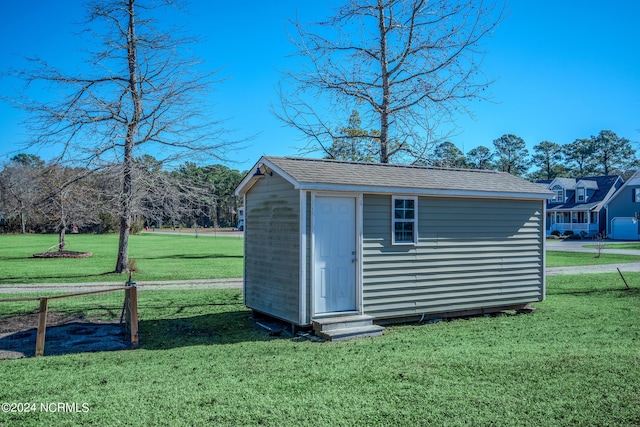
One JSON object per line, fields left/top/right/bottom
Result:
{"left": 0, "top": 312, "right": 129, "bottom": 359}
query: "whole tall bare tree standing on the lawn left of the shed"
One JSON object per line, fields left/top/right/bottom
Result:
{"left": 8, "top": 0, "right": 231, "bottom": 273}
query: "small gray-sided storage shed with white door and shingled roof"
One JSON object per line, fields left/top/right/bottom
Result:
{"left": 236, "top": 157, "right": 553, "bottom": 338}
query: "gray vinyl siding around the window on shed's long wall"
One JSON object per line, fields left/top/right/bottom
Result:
{"left": 363, "top": 195, "right": 544, "bottom": 318}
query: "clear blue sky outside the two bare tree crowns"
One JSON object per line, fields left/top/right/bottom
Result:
{"left": 0, "top": 0, "right": 640, "bottom": 170}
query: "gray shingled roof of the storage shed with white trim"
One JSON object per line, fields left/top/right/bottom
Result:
{"left": 236, "top": 156, "right": 553, "bottom": 199}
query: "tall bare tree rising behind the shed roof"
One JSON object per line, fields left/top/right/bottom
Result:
{"left": 276, "top": 0, "right": 502, "bottom": 163}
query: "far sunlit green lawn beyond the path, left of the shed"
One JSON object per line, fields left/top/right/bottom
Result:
{"left": 0, "top": 233, "right": 243, "bottom": 284}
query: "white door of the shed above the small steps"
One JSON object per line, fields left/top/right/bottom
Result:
{"left": 313, "top": 196, "right": 357, "bottom": 314}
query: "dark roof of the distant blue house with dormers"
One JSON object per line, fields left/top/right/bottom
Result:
{"left": 536, "top": 175, "right": 622, "bottom": 212}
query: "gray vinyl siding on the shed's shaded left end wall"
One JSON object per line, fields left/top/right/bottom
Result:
{"left": 244, "top": 174, "right": 300, "bottom": 323}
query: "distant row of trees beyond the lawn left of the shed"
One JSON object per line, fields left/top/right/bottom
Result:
{"left": 0, "top": 154, "right": 244, "bottom": 239}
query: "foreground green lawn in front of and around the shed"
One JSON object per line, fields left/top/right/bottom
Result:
{"left": 0, "top": 273, "right": 640, "bottom": 426}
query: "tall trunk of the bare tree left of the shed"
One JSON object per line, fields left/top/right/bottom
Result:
{"left": 115, "top": 0, "right": 142, "bottom": 273}
